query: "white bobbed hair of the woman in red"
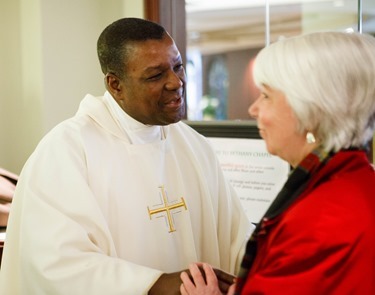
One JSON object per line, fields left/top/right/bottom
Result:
{"left": 254, "top": 32, "right": 375, "bottom": 151}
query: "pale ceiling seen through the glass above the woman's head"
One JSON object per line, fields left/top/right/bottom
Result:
{"left": 186, "top": 0, "right": 375, "bottom": 54}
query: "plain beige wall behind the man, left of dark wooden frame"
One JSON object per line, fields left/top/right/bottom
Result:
{"left": 0, "top": 0, "right": 143, "bottom": 173}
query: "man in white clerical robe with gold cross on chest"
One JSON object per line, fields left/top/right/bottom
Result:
{"left": 0, "top": 18, "right": 251, "bottom": 295}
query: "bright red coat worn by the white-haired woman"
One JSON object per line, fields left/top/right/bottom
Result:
{"left": 242, "top": 151, "right": 375, "bottom": 295}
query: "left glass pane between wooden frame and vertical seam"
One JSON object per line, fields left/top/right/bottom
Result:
{"left": 186, "top": 0, "right": 265, "bottom": 120}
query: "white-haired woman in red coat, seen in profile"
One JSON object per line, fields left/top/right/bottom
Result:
{"left": 181, "top": 32, "right": 375, "bottom": 295}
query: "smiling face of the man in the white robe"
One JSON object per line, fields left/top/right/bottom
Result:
{"left": 109, "top": 35, "right": 185, "bottom": 125}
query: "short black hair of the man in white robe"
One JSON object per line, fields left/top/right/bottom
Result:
{"left": 97, "top": 17, "right": 167, "bottom": 78}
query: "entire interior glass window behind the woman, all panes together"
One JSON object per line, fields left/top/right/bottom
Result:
{"left": 186, "top": 0, "right": 375, "bottom": 120}
